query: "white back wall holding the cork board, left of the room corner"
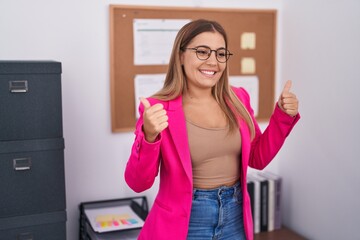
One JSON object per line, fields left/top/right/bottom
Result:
{"left": 0, "top": 0, "right": 281, "bottom": 240}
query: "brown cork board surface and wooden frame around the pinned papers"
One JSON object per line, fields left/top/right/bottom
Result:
{"left": 110, "top": 5, "right": 276, "bottom": 132}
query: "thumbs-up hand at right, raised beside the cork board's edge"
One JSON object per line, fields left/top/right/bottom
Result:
{"left": 278, "top": 80, "right": 299, "bottom": 117}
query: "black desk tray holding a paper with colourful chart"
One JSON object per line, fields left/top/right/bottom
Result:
{"left": 79, "top": 196, "right": 149, "bottom": 240}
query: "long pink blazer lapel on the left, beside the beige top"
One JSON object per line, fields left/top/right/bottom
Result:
{"left": 167, "top": 96, "right": 192, "bottom": 182}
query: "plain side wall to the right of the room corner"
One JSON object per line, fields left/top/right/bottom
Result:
{"left": 279, "top": 0, "right": 360, "bottom": 240}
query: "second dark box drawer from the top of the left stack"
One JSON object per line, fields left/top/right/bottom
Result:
{"left": 0, "top": 138, "right": 66, "bottom": 217}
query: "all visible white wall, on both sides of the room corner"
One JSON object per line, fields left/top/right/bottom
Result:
{"left": 0, "top": 0, "right": 360, "bottom": 240}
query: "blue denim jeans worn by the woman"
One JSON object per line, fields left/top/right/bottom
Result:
{"left": 187, "top": 183, "right": 246, "bottom": 240}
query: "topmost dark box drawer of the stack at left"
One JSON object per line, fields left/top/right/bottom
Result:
{"left": 0, "top": 61, "right": 63, "bottom": 141}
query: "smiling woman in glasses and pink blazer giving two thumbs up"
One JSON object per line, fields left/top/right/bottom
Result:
{"left": 125, "top": 20, "right": 300, "bottom": 240}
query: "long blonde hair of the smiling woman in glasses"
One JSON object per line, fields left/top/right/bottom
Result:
{"left": 152, "top": 19, "right": 255, "bottom": 139}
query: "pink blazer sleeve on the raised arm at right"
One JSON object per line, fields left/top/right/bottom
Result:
{"left": 237, "top": 88, "right": 300, "bottom": 170}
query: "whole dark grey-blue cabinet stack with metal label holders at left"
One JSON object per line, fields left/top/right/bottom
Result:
{"left": 0, "top": 61, "right": 66, "bottom": 240}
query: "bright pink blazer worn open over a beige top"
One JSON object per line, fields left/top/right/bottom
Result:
{"left": 125, "top": 88, "right": 300, "bottom": 240}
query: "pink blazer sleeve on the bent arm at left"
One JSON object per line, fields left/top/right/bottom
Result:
{"left": 124, "top": 100, "right": 161, "bottom": 192}
